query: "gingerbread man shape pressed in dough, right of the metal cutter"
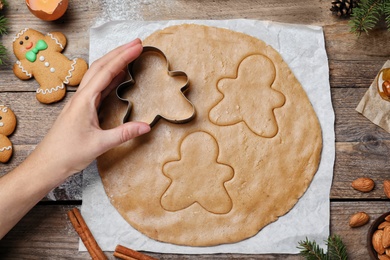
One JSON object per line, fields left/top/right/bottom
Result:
{"left": 209, "top": 54, "right": 286, "bottom": 138}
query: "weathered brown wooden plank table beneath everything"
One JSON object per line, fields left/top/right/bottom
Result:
{"left": 0, "top": 0, "right": 390, "bottom": 259}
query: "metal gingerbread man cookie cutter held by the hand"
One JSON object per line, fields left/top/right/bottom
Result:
{"left": 116, "top": 46, "right": 195, "bottom": 127}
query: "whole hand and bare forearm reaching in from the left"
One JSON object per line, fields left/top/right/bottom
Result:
{"left": 0, "top": 39, "right": 150, "bottom": 239}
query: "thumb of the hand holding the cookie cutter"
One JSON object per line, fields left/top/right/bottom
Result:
{"left": 103, "top": 122, "right": 150, "bottom": 151}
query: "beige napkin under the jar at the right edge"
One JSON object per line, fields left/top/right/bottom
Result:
{"left": 356, "top": 60, "right": 390, "bottom": 133}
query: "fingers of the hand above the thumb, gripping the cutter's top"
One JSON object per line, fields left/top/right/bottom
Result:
{"left": 79, "top": 39, "right": 142, "bottom": 92}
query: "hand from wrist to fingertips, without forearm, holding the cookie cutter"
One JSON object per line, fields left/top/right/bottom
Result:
{"left": 38, "top": 39, "right": 150, "bottom": 175}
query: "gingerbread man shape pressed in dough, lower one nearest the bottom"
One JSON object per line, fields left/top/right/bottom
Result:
{"left": 161, "top": 132, "right": 234, "bottom": 214}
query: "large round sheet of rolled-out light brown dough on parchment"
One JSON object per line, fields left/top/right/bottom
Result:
{"left": 98, "top": 24, "right": 322, "bottom": 246}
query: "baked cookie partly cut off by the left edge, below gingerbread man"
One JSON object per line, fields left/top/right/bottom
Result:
{"left": 0, "top": 105, "right": 16, "bottom": 163}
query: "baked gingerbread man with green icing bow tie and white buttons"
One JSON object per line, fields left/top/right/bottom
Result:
{"left": 13, "top": 28, "right": 88, "bottom": 104}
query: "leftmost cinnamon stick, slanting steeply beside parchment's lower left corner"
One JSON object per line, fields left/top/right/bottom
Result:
{"left": 68, "top": 208, "right": 107, "bottom": 260}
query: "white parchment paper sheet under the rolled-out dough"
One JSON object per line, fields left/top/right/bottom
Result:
{"left": 80, "top": 20, "right": 335, "bottom": 254}
